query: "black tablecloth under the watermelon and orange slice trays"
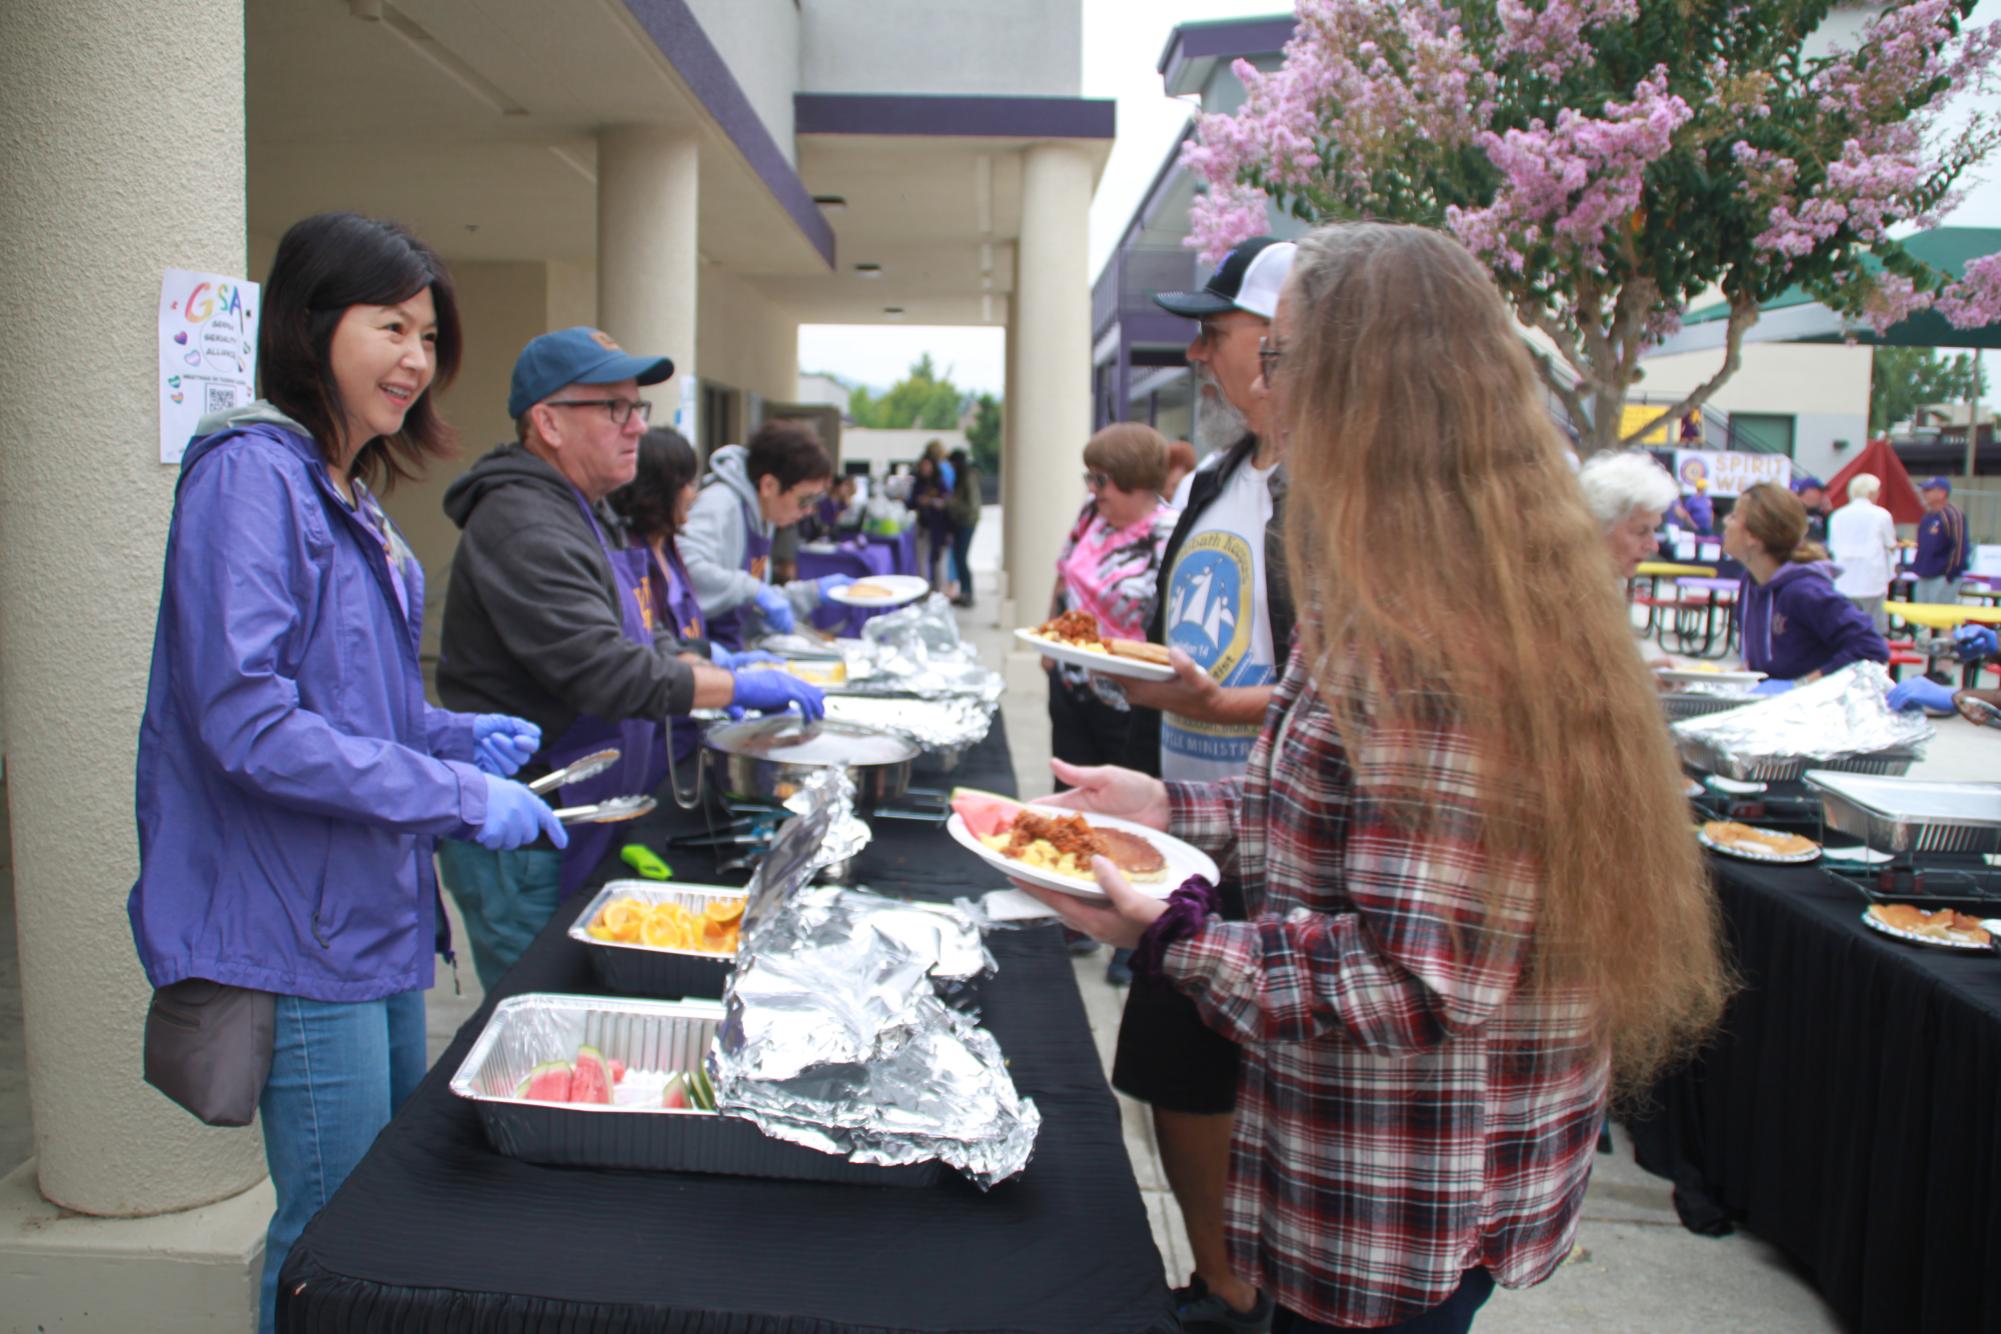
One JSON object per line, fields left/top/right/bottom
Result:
{"left": 278, "top": 718, "right": 1175, "bottom": 1334}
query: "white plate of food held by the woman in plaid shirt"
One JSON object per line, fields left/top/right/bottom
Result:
{"left": 944, "top": 792, "right": 1219, "bottom": 898}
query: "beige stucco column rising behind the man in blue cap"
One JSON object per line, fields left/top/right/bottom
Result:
{"left": 598, "top": 126, "right": 702, "bottom": 412}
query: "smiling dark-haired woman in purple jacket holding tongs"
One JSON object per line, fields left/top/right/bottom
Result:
{"left": 128, "top": 214, "right": 566, "bottom": 1330}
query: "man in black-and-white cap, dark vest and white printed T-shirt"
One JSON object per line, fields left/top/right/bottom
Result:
{"left": 1088, "top": 236, "right": 1297, "bottom": 1332}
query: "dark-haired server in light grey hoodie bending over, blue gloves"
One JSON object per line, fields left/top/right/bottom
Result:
{"left": 680, "top": 418, "right": 854, "bottom": 650}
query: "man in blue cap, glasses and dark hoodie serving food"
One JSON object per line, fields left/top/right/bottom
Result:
{"left": 438, "top": 328, "right": 824, "bottom": 988}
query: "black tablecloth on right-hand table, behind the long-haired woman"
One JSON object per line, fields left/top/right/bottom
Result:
{"left": 1633, "top": 858, "right": 2001, "bottom": 1334}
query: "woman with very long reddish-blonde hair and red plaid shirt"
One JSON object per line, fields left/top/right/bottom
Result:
{"left": 1043, "top": 224, "right": 1727, "bottom": 1332}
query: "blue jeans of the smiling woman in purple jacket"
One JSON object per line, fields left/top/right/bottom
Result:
{"left": 258, "top": 992, "right": 426, "bottom": 1334}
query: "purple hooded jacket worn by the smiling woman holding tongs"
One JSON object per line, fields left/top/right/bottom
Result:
{"left": 126, "top": 404, "right": 486, "bottom": 1002}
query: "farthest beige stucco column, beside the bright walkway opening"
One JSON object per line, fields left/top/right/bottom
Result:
{"left": 1007, "top": 144, "right": 1091, "bottom": 624}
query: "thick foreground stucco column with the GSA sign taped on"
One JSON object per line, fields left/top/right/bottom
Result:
{"left": 0, "top": 0, "right": 264, "bottom": 1224}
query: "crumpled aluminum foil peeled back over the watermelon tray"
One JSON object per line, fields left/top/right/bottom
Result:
{"left": 714, "top": 770, "right": 1043, "bottom": 1188}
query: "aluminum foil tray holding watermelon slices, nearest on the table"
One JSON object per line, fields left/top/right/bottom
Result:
{"left": 452, "top": 994, "right": 942, "bottom": 1186}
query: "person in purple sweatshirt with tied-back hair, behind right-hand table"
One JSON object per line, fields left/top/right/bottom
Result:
{"left": 1723, "top": 482, "right": 1889, "bottom": 692}
